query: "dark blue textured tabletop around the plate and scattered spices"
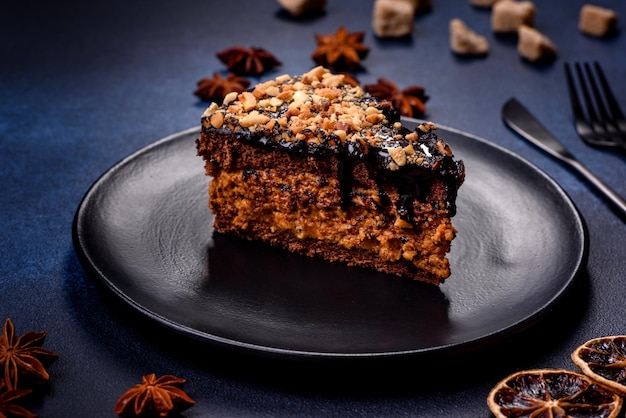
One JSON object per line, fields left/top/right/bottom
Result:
{"left": 0, "top": 0, "right": 626, "bottom": 417}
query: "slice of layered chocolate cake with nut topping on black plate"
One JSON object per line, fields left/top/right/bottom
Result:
{"left": 197, "top": 67, "right": 465, "bottom": 284}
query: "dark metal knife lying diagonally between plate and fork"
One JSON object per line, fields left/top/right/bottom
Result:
{"left": 502, "top": 98, "right": 626, "bottom": 219}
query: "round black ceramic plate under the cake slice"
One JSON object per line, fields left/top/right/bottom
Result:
{"left": 73, "top": 121, "right": 587, "bottom": 358}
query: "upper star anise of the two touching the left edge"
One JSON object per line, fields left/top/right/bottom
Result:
{"left": 0, "top": 318, "right": 59, "bottom": 390}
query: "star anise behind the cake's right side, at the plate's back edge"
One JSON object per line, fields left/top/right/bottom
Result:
{"left": 364, "top": 77, "right": 430, "bottom": 118}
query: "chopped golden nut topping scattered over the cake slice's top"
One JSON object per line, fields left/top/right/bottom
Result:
{"left": 202, "top": 66, "right": 451, "bottom": 175}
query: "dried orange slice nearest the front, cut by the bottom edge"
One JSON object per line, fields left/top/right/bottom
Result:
{"left": 487, "top": 369, "right": 622, "bottom": 418}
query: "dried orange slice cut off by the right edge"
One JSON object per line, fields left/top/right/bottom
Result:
{"left": 572, "top": 335, "right": 626, "bottom": 396}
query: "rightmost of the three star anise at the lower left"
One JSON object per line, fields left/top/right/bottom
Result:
{"left": 113, "top": 373, "right": 196, "bottom": 417}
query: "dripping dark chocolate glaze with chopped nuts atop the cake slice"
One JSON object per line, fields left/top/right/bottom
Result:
{"left": 202, "top": 67, "right": 465, "bottom": 222}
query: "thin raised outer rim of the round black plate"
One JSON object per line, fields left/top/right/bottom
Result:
{"left": 72, "top": 121, "right": 589, "bottom": 359}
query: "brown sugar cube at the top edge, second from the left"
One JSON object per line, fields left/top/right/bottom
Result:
{"left": 372, "top": 0, "right": 415, "bottom": 38}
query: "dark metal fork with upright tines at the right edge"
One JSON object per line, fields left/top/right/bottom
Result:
{"left": 565, "top": 62, "right": 626, "bottom": 152}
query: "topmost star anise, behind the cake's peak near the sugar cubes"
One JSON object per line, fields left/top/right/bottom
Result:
{"left": 311, "top": 26, "right": 369, "bottom": 71}
